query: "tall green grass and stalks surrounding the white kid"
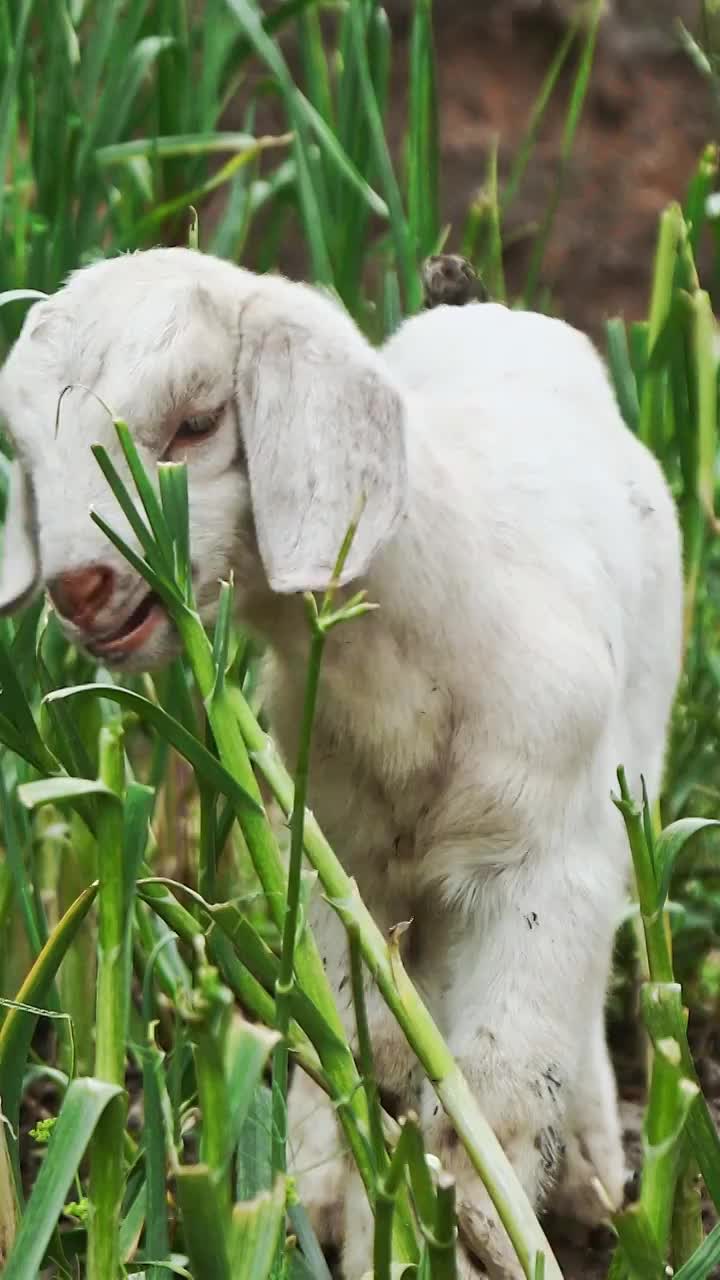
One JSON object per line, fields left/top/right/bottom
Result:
{"left": 0, "top": 0, "right": 720, "bottom": 1280}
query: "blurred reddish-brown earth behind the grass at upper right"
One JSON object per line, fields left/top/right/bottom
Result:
{"left": 242, "top": 0, "right": 720, "bottom": 340}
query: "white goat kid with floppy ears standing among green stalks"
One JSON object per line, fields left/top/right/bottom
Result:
{"left": 0, "top": 250, "right": 682, "bottom": 1280}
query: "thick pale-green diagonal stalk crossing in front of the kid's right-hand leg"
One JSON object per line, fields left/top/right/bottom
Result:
{"left": 228, "top": 690, "right": 561, "bottom": 1280}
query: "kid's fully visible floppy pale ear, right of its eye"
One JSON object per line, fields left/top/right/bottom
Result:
{"left": 237, "top": 316, "right": 407, "bottom": 593}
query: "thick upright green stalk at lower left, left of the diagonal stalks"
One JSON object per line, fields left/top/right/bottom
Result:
{"left": 87, "top": 728, "right": 129, "bottom": 1280}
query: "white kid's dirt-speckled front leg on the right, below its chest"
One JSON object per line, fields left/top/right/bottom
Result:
{"left": 424, "top": 820, "right": 624, "bottom": 1280}
